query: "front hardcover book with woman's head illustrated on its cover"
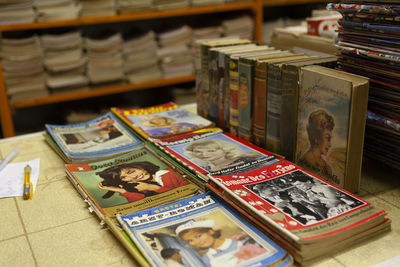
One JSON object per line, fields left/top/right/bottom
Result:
{"left": 295, "top": 65, "right": 369, "bottom": 192}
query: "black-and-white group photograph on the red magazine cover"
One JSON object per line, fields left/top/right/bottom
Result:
{"left": 245, "top": 170, "right": 365, "bottom": 225}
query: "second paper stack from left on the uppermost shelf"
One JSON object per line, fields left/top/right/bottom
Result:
{"left": 33, "top": 0, "right": 82, "bottom": 21}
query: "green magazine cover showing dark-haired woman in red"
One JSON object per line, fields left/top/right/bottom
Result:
{"left": 65, "top": 147, "right": 199, "bottom": 218}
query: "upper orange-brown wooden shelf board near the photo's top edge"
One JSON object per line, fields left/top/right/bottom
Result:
{"left": 0, "top": 1, "right": 257, "bottom": 31}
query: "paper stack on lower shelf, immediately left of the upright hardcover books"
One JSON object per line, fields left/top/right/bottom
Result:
{"left": 158, "top": 25, "right": 194, "bottom": 78}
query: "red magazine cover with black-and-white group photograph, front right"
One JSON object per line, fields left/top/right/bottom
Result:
{"left": 210, "top": 160, "right": 385, "bottom": 244}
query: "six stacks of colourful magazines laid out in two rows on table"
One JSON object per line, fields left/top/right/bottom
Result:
{"left": 45, "top": 103, "right": 390, "bottom": 266}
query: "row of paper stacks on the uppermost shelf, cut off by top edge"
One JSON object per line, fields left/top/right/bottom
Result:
{"left": 0, "top": 0, "right": 246, "bottom": 24}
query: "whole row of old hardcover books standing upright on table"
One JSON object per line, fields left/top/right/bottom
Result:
{"left": 195, "top": 38, "right": 369, "bottom": 195}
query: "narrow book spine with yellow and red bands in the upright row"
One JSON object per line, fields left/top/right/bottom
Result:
{"left": 229, "top": 58, "right": 239, "bottom": 136}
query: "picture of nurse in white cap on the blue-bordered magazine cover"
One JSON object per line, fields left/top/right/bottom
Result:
{"left": 141, "top": 210, "right": 274, "bottom": 267}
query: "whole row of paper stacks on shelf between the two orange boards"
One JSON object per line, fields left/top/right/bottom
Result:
{"left": 0, "top": 16, "right": 253, "bottom": 101}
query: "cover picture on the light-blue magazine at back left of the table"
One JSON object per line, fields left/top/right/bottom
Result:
{"left": 59, "top": 120, "right": 132, "bottom": 153}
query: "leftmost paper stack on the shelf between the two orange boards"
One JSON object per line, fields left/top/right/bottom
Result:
{"left": 1, "top": 32, "right": 48, "bottom": 100}
